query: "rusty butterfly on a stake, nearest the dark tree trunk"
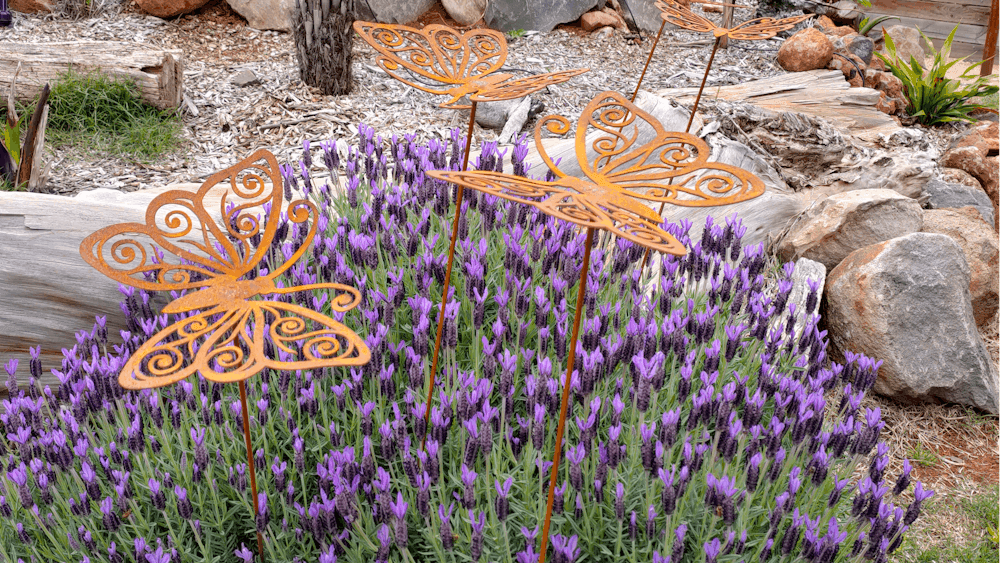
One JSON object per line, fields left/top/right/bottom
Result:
{"left": 354, "top": 21, "right": 590, "bottom": 445}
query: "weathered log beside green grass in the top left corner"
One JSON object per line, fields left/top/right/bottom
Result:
{"left": 0, "top": 41, "right": 184, "bottom": 109}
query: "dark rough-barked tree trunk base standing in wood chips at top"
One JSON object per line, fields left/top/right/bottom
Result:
{"left": 293, "top": 0, "right": 356, "bottom": 96}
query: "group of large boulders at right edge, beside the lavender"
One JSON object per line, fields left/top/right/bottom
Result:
{"left": 774, "top": 185, "right": 1000, "bottom": 414}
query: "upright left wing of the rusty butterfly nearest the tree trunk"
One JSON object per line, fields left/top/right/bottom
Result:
{"left": 354, "top": 21, "right": 507, "bottom": 94}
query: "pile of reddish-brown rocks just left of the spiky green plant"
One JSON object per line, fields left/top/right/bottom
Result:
{"left": 778, "top": 16, "right": 922, "bottom": 115}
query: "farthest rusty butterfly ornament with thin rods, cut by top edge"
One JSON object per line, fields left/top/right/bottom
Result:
{"left": 632, "top": 0, "right": 813, "bottom": 129}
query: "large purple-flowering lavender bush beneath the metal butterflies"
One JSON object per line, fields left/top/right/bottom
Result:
{"left": 0, "top": 126, "right": 931, "bottom": 563}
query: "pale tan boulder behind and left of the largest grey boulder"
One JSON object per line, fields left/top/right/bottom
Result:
{"left": 776, "top": 190, "right": 923, "bottom": 270}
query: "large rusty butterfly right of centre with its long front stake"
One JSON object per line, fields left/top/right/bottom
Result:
{"left": 427, "top": 92, "right": 764, "bottom": 563}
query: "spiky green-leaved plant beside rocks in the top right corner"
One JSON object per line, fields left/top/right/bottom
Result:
{"left": 876, "top": 26, "right": 1000, "bottom": 125}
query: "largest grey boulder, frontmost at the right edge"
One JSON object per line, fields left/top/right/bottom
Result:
{"left": 825, "top": 233, "right": 1000, "bottom": 414}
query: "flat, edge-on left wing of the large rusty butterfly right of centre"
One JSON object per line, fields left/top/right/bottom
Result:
{"left": 427, "top": 170, "right": 686, "bottom": 255}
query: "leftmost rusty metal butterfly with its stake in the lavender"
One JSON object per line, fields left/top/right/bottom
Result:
{"left": 80, "top": 150, "right": 371, "bottom": 558}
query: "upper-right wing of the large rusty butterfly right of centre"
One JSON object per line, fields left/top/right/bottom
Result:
{"left": 564, "top": 92, "right": 764, "bottom": 207}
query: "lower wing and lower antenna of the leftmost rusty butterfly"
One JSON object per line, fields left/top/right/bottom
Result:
{"left": 119, "top": 284, "right": 371, "bottom": 389}
